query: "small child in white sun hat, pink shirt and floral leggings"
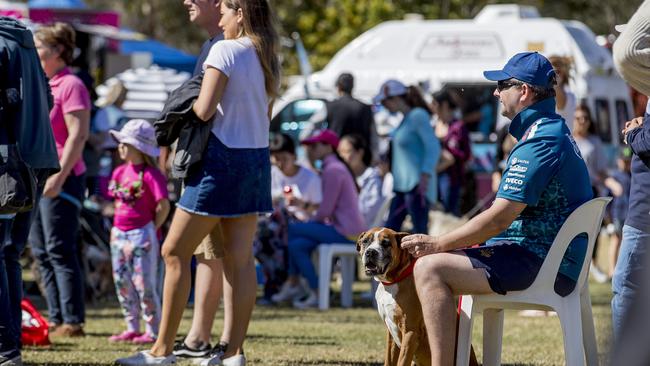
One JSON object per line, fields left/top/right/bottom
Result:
{"left": 109, "top": 119, "right": 169, "bottom": 344}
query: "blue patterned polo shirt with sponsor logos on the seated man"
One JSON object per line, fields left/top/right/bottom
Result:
{"left": 487, "top": 98, "right": 592, "bottom": 281}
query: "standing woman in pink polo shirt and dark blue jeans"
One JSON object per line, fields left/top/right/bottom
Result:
{"left": 30, "top": 23, "right": 90, "bottom": 337}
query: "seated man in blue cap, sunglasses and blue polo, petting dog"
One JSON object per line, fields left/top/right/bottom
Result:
{"left": 402, "top": 52, "right": 592, "bottom": 365}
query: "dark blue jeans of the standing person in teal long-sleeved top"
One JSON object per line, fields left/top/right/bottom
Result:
{"left": 386, "top": 187, "right": 429, "bottom": 234}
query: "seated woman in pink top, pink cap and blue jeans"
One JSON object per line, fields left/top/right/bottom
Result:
{"left": 272, "top": 130, "right": 366, "bottom": 309}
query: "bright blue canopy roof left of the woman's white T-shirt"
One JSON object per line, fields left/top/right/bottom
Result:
{"left": 120, "top": 39, "right": 196, "bottom": 73}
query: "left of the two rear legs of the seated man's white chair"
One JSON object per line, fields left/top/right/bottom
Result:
{"left": 555, "top": 299, "right": 591, "bottom": 366}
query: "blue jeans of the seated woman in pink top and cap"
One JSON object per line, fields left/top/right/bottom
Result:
{"left": 288, "top": 222, "right": 352, "bottom": 290}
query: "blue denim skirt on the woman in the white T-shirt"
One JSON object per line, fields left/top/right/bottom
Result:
{"left": 177, "top": 134, "right": 273, "bottom": 217}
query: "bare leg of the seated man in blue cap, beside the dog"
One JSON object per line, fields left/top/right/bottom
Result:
{"left": 413, "top": 251, "right": 493, "bottom": 366}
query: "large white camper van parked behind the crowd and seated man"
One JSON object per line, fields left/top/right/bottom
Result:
{"left": 271, "top": 5, "right": 632, "bottom": 200}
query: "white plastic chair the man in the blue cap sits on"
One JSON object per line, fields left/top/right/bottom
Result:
{"left": 456, "top": 197, "right": 611, "bottom": 366}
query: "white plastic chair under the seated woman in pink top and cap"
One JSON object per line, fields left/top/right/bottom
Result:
{"left": 318, "top": 193, "right": 392, "bottom": 310}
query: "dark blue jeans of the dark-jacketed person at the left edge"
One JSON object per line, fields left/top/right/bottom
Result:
{"left": 0, "top": 169, "right": 49, "bottom": 359}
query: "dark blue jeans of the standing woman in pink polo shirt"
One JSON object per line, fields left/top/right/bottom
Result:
{"left": 29, "top": 175, "right": 84, "bottom": 324}
